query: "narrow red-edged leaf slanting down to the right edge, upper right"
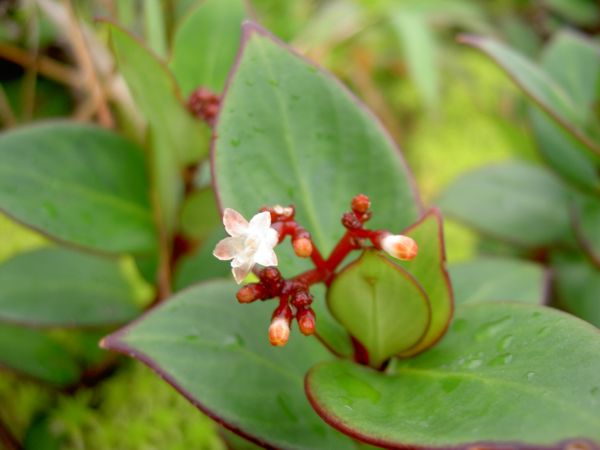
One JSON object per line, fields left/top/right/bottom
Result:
{"left": 461, "top": 36, "right": 600, "bottom": 158}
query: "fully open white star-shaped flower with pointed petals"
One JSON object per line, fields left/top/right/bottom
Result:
{"left": 213, "top": 208, "right": 279, "bottom": 284}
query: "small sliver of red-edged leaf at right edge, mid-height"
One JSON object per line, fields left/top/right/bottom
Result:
{"left": 571, "top": 195, "right": 600, "bottom": 267}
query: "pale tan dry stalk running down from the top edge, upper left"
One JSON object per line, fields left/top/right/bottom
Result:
{"left": 63, "top": 0, "right": 114, "bottom": 128}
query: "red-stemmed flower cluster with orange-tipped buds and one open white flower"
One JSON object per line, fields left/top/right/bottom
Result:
{"left": 213, "top": 194, "right": 418, "bottom": 346}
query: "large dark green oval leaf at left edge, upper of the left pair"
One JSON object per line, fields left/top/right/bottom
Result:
{"left": 0, "top": 122, "right": 156, "bottom": 253}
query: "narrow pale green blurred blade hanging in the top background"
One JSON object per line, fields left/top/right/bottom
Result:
{"left": 391, "top": 8, "right": 440, "bottom": 108}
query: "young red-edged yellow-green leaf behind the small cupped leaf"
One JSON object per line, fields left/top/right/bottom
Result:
{"left": 397, "top": 209, "right": 454, "bottom": 356}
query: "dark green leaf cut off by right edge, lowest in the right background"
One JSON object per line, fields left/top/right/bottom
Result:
{"left": 552, "top": 256, "right": 600, "bottom": 328}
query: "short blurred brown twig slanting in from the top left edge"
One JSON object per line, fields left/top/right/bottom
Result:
{"left": 0, "top": 42, "right": 81, "bottom": 88}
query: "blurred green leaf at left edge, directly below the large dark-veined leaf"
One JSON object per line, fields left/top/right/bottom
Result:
{"left": 0, "top": 248, "right": 140, "bottom": 327}
